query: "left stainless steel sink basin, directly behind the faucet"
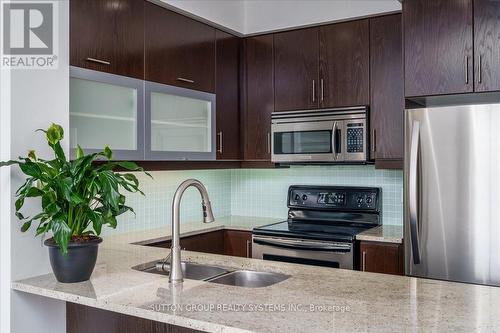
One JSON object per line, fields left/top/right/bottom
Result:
{"left": 132, "top": 261, "right": 230, "bottom": 280}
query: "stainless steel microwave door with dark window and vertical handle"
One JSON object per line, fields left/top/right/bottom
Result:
{"left": 271, "top": 120, "right": 343, "bottom": 163}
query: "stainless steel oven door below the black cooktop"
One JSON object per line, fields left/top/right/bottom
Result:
{"left": 252, "top": 235, "right": 354, "bottom": 269}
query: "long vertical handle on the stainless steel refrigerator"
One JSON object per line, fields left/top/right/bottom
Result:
{"left": 409, "top": 121, "right": 420, "bottom": 265}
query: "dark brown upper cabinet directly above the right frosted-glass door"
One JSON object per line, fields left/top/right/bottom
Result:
{"left": 145, "top": 2, "right": 215, "bottom": 93}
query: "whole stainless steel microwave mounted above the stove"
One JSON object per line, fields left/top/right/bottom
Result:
{"left": 271, "top": 107, "right": 369, "bottom": 163}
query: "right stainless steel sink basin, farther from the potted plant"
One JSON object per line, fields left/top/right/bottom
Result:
{"left": 208, "top": 271, "right": 290, "bottom": 288}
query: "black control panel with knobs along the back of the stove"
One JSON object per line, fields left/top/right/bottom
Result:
{"left": 288, "top": 185, "right": 382, "bottom": 211}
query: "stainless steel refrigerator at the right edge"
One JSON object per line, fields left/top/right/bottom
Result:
{"left": 404, "top": 104, "right": 500, "bottom": 286}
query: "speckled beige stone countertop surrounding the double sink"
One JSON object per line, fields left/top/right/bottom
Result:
{"left": 12, "top": 217, "right": 500, "bottom": 333}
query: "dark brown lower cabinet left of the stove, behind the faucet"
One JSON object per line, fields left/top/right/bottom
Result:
{"left": 149, "top": 230, "right": 252, "bottom": 258}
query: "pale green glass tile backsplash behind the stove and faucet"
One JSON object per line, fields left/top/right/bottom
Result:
{"left": 112, "top": 165, "right": 403, "bottom": 234}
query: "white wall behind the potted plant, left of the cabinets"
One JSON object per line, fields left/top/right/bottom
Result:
{"left": 0, "top": 0, "right": 69, "bottom": 333}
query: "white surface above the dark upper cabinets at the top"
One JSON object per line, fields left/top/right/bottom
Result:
{"left": 154, "top": 0, "right": 401, "bottom": 35}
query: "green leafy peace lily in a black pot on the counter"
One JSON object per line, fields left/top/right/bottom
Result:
{"left": 0, "top": 124, "right": 149, "bottom": 282}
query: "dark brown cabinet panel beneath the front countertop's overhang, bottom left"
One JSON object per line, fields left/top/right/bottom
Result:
{"left": 66, "top": 302, "right": 202, "bottom": 333}
